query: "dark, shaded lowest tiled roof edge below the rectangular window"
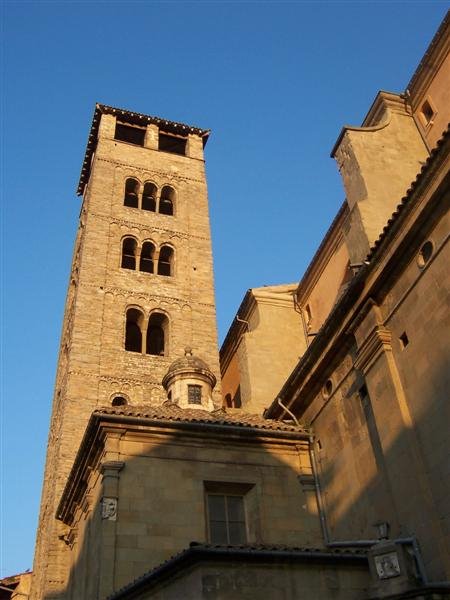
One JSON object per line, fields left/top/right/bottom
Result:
{"left": 107, "top": 542, "right": 367, "bottom": 600}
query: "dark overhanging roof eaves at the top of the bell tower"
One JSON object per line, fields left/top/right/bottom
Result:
{"left": 77, "top": 102, "right": 211, "bottom": 196}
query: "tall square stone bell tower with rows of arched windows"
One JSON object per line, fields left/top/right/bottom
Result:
{"left": 31, "top": 104, "right": 220, "bottom": 599}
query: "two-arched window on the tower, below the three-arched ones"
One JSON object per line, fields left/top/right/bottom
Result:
{"left": 125, "top": 308, "right": 169, "bottom": 356}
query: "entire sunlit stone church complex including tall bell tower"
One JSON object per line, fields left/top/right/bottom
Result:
{"left": 4, "top": 8, "right": 450, "bottom": 600}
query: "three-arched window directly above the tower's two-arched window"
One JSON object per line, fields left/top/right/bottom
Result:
{"left": 120, "top": 237, "right": 175, "bottom": 277}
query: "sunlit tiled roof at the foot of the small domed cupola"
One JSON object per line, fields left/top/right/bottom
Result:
{"left": 93, "top": 402, "right": 307, "bottom": 433}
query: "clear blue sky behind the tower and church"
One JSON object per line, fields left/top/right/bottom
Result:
{"left": 0, "top": 1, "right": 448, "bottom": 575}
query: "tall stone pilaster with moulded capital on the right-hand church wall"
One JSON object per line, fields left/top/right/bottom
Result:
{"left": 354, "top": 303, "right": 445, "bottom": 576}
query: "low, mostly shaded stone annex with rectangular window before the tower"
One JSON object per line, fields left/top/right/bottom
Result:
{"left": 40, "top": 409, "right": 368, "bottom": 600}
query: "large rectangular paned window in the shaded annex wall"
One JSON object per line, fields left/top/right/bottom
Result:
{"left": 207, "top": 493, "right": 247, "bottom": 545}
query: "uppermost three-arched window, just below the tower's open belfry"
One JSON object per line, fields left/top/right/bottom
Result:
{"left": 123, "top": 177, "right": 176, "bottom": 215}
